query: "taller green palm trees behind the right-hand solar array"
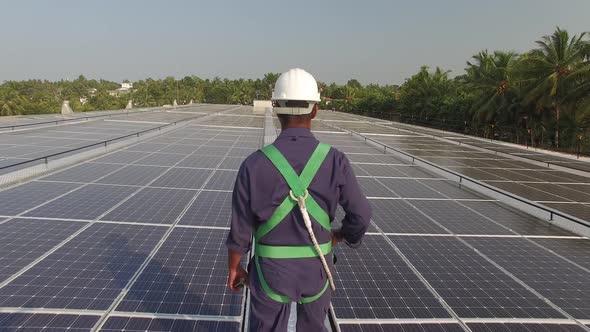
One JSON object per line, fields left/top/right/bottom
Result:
{"left": 353, "top": 28, "right": 590, "bottom": 153}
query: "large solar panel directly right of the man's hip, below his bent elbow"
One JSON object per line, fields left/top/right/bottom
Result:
{"left": 332, "top": 235, "right": 449, "bottom": 319}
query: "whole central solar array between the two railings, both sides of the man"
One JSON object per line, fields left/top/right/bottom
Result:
{"left": 0, "top": 106, "right": 590, "bottom": 331}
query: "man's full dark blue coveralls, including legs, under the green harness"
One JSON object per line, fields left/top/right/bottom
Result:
{"left": 226, "top": 128, "right": 371, "bottom": 331}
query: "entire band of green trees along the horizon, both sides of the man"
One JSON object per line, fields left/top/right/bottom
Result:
{"left": 0, "top": 28, "right": 590, "bottom": 151}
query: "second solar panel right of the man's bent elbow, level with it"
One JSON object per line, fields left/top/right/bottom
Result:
{"left": 409, "top": 200, "right": 514, "bottom": 235}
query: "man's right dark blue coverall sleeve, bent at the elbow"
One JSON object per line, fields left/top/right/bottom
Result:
{"left": 340, "top": 154, "right": 371, "bottom": 248}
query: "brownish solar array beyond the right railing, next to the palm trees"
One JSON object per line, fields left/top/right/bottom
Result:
{"left": 321, "top": 112, "right": 590, "bottom": 222}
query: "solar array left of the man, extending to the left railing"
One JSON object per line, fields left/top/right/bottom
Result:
{"left": 0, "top": 106, "right": 262, "bottom": 331}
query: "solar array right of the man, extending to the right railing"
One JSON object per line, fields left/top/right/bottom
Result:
{"left": 316, "top": 123, "right": 590, "bottom": 331}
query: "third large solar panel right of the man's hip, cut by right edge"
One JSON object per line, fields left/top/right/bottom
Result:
{"left": 467, "top": 238, "right": 590, "bottom": 319}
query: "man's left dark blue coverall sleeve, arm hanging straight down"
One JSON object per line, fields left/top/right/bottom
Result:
{"left": 225, "top": 164, "right": 254, "bottom": 254}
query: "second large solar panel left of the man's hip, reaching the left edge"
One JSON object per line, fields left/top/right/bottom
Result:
{"left": 0, "top": 223, "right": 166, "bottom": 310}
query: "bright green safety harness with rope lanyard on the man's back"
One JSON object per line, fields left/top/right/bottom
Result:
{"left": 254, "top": 143, "right": 333, "bottom": 304}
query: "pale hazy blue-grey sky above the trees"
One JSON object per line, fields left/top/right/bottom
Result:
{"left": 0, "top": 0, "right": 590, "bottom": 84}
